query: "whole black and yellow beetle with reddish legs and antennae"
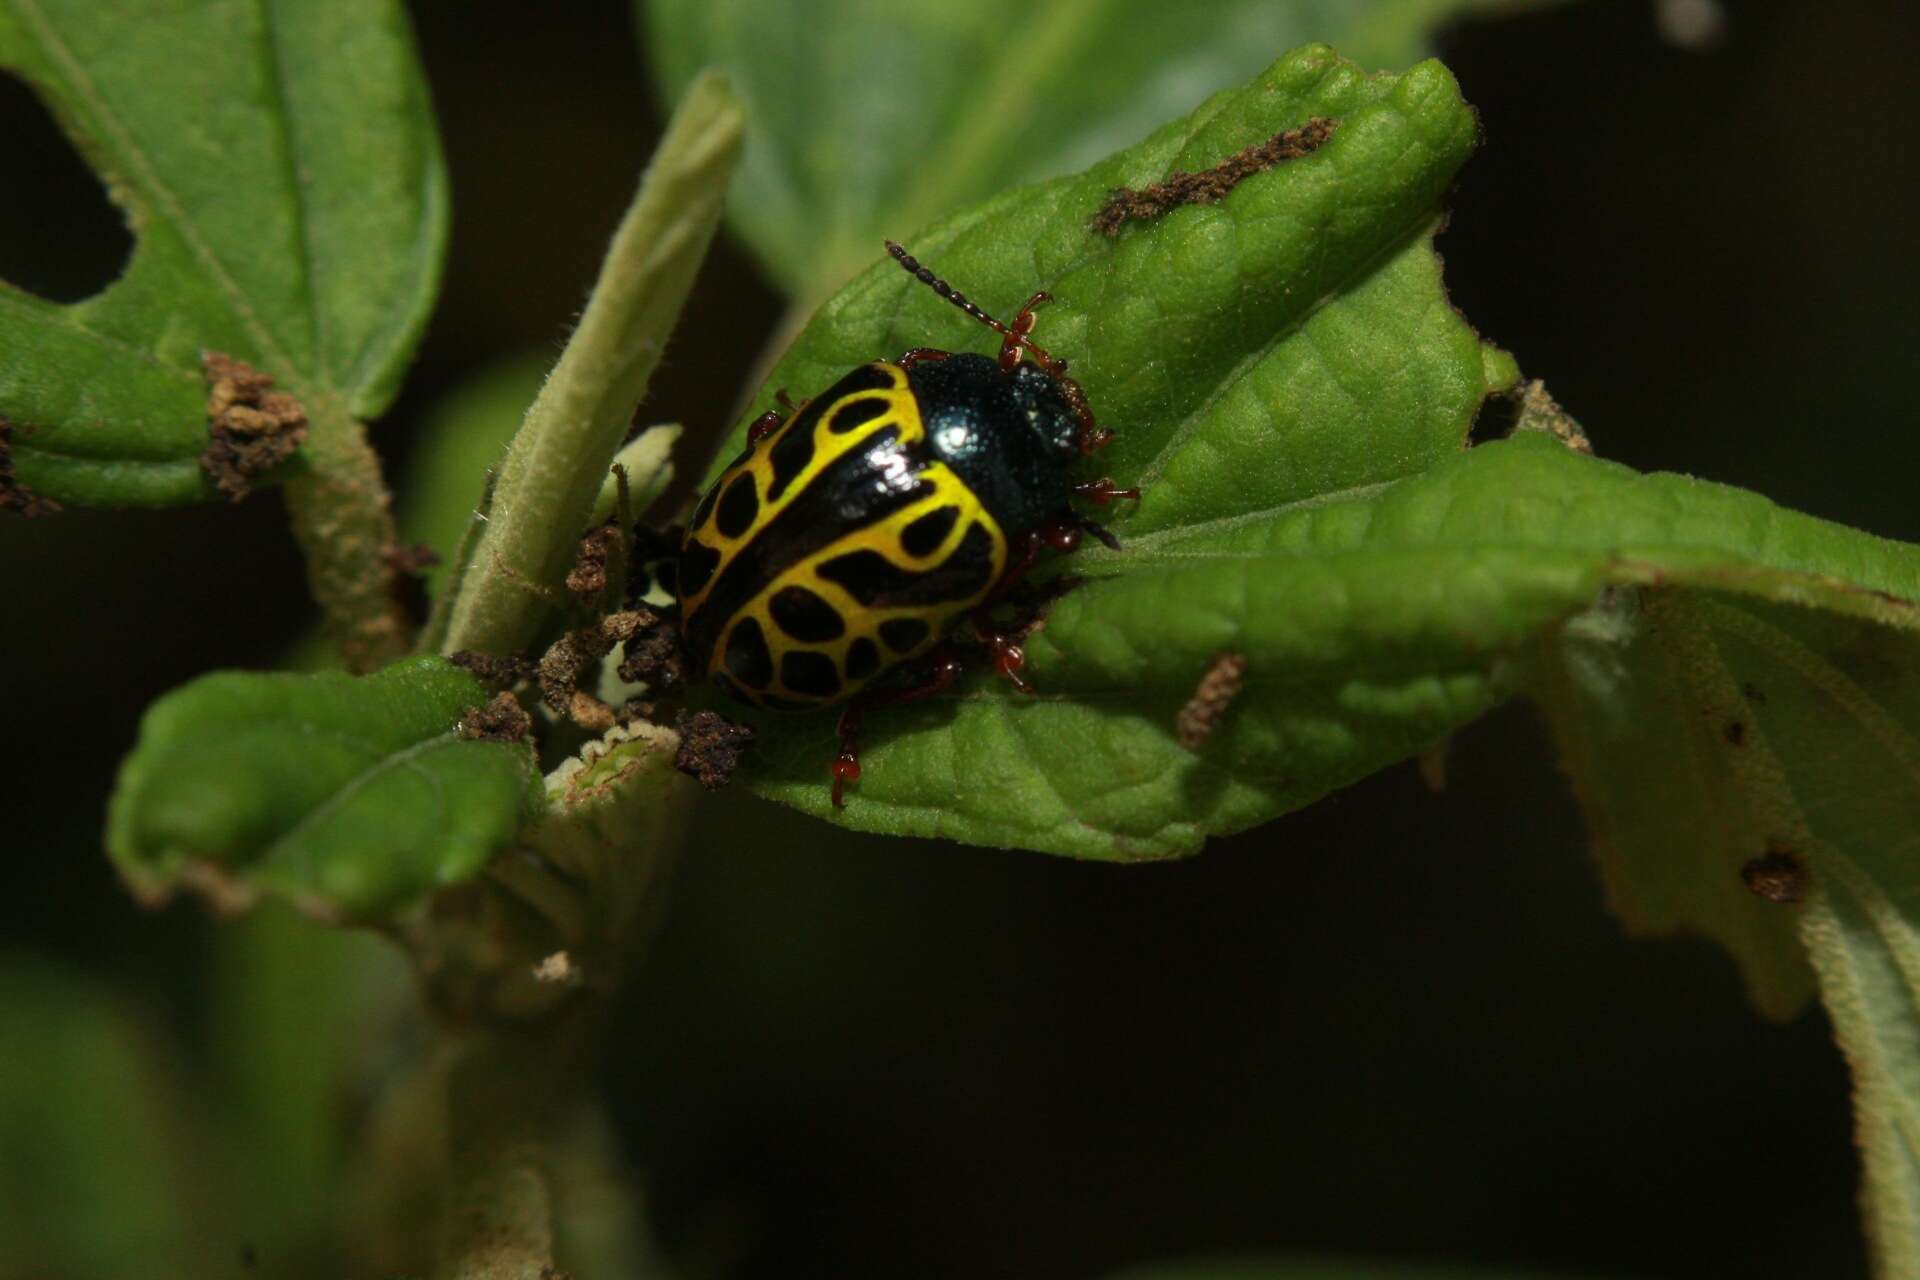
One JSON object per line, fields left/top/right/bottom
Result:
{"left": 676, "top": 240, "right": 1140, "bottom": 808}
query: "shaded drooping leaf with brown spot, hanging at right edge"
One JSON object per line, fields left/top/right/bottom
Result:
{"left": 1542, "top": 594, "right": 1920, "bottom": 1276}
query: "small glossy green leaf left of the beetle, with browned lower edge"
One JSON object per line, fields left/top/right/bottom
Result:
{"left": 108, "top": 658, "right": 538, "bottom": 921}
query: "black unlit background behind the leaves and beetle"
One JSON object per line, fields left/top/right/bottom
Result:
{"left": 0, "top": 0, "right": 1920, "bottom": 1278}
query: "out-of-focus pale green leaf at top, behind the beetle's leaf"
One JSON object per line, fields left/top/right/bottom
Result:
{"left": 636, "top": 0, "right": 1543, "bottom": 301}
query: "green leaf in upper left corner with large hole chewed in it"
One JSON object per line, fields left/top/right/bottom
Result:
{"left": 0, "top": 0, "right": 447, "bottom": 507}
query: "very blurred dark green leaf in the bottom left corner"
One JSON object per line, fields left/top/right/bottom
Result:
{"left": 0, "top": 956, "right": 206, "bottom": 1280}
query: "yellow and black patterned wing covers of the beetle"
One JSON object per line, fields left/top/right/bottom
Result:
{"left": 680, "top": 361, "right": 1008, "bottom": 710}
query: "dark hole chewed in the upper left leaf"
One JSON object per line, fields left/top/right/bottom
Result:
{"left": 0, "top": 71, "right": 132, "bottom": 301}
